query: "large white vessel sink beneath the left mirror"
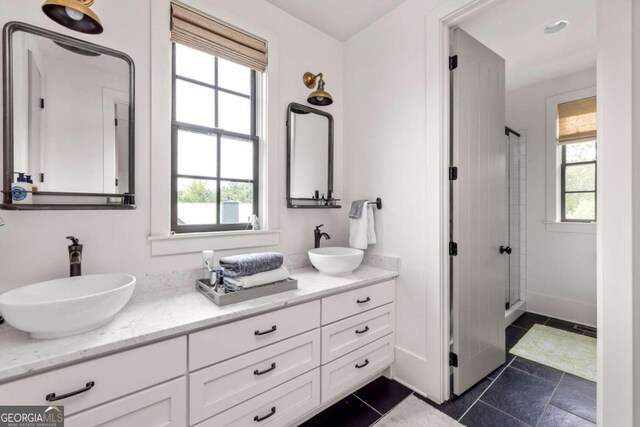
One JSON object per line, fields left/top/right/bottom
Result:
{"left": 0, "top": 274, "right": 136, "bottom": 338}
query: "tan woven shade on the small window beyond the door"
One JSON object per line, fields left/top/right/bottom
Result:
{"left": 558, "top": 96, "right": 597, "bottom": 145}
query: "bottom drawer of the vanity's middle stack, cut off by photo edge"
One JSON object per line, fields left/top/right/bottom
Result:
{"left": 198, "top": 368, "right": 320, "bottom": 427}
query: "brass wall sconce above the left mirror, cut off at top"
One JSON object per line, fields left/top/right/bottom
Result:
{"left": 42, "top": 0, "right": 104, "bottom": 34}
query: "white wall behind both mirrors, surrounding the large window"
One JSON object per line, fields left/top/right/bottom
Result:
{"left": 0, "top": 0, "right": 347, "bottom": 292}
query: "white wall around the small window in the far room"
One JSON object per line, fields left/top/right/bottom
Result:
{"left": 506, "top": 69, "right": 596, "bottom": 326}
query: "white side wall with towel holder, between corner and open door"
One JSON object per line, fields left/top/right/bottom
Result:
{"left": 344, "top": 0, "right": 442, "bottom": 400}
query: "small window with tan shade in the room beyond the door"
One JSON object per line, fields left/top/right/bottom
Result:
{"left": 558, "top": 96, "right": 597, "bottom": 222}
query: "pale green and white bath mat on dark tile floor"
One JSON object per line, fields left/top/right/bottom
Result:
{"left": 509, "top": 324, "right": 597, "bottom": 381}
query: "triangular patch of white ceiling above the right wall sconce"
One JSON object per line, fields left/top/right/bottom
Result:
{"left": 267, "top": 0, "right": 405, "bottom": 41}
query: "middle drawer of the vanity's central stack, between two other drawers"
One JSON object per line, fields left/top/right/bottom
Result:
{"left": 189, "top": 329, "right": 320, "bottom": 424}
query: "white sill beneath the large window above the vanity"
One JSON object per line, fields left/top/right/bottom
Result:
{"left": 147, "top": 230, "right": 280, "bottom": 256}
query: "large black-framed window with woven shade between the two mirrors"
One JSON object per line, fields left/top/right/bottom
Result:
{"left": 171, "top": 3, "right": 267, "bottom": 233}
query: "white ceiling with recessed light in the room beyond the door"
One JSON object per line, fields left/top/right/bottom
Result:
{"left": 460, "top": 0, "right": 596, "bottom": 90}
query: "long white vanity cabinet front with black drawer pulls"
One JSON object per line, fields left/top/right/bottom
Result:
{"left": 0, "top": 280, "right": 395, "bottom": 427}
